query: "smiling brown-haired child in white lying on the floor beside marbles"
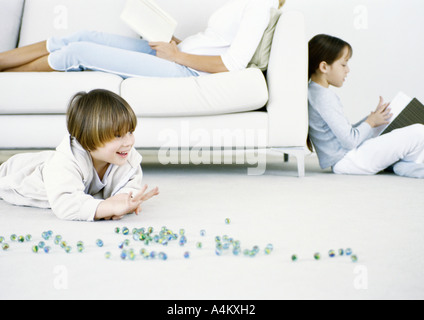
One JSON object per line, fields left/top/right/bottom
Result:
{"left": 0, "top": 90, "right": 159, "bottom": 221}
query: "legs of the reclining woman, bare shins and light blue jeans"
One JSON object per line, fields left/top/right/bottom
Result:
{"left": 0, "top": 31, "right": 198, "bottom": 78}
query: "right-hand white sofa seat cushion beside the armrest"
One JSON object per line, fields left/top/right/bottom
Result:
{"left": 121, "top": 68, "right": 268, "bottom": 117}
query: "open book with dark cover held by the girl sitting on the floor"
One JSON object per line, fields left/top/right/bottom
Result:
{"left": 377, "top": 92, "right": 424, "bottom": 135}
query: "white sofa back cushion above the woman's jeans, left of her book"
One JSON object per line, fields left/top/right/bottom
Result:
{"left": 19, "top": 0, "right": 137, "bottom": 47}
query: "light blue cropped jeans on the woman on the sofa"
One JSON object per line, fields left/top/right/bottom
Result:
{"left": 47, "top": 31, "right": 199, "bottom": 78}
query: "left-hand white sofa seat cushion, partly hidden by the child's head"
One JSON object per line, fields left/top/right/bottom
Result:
{"left": 0, "top": 72, "right": 122, "bottom": 114}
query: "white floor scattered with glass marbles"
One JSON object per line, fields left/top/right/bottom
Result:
{"left": 0, "top": 152, "right": 424, "bottom": 300}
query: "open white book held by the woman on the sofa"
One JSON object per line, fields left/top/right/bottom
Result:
{"left": 121, "top": 0, "right": 177, "bottom": 42}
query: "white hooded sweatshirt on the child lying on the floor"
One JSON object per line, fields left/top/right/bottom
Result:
{"left": 0, "top": 135, "right": 143, "bottom": 221}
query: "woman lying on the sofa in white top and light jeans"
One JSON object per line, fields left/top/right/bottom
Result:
{"left": 0, "top": 0, "right": 285, "bottom": 78}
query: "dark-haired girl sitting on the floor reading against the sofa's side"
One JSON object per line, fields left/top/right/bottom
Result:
{"left": 308, "top": 35, "right": 424, "bottom": 179}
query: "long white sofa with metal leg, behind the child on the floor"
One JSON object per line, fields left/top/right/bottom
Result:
{"left": 0, "top": 0, "right": 308, "bottom": 176}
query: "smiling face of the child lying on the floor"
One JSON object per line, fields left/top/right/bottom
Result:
{"left": 90, "top": 132, "right": 135, "bottom": 166}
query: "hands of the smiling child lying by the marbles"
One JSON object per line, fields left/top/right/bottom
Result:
{"left": 94, "top": 185, "right": 159, "bottom": 220}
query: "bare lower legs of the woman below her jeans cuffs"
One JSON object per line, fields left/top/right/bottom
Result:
{"left": 0, "top": 41, "right": 49, "bottom": 71}
